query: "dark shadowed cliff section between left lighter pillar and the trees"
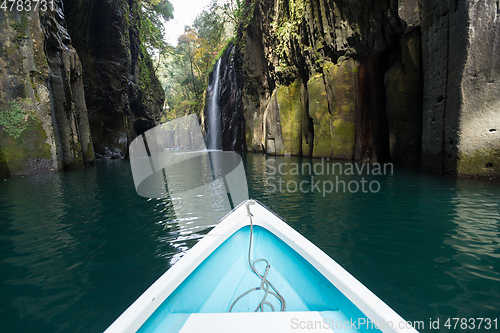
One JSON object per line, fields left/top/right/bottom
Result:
{"left": 64, "top": 0, "right": 164, "bottom": 158}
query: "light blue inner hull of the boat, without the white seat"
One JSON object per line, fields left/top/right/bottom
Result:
{"left": 138, "top": 226, "right": 379, "bottom": 333}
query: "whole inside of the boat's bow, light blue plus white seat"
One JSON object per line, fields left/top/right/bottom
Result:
{"left": 138, "top": 226, "right": 378, "bottom": 333}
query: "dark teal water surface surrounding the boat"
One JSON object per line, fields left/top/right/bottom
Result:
{"left": 0, "top": 154, "right": 500, "bottom": 332}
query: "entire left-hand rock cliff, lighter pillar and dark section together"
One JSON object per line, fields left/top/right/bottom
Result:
{"left": 0, "top": 0, "right": 164, "bottom": 177}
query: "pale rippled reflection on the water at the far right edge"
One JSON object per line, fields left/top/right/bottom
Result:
{"left": 432, "top": 180, "right": 500, "bottom": 318}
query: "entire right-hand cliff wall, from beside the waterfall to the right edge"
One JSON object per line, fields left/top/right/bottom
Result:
{"left": 227, "top": 0, "right": 500, "bottom": 176}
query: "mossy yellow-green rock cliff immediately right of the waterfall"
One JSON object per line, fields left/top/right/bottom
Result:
{"left": 237, "top": 0, "right": 404, "bottom": 161}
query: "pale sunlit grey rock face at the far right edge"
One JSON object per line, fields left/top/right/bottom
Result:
{"left": 458, "top": 1, "right": 500, "bottom": 176}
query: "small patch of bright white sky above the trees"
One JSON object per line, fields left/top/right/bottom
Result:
{"left": 165, "top": 0, "right": 211, "bottom": 45}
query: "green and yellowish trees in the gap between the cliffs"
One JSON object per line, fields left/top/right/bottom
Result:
{"left": 140, "top": 0, "right": 257, "bottom": 121}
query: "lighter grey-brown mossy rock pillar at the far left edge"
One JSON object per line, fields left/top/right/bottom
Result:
{"left": 0, "top": 1, "right": 89, "bottom": 176}
